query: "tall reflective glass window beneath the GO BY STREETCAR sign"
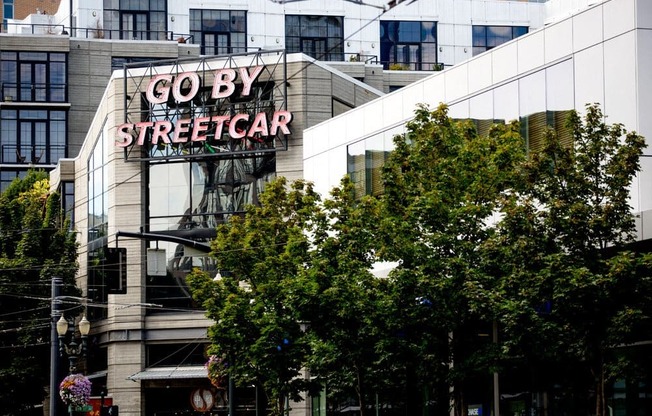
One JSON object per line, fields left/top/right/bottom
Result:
{"left": 146, "top": 155, "right": 276, "bottom": 313}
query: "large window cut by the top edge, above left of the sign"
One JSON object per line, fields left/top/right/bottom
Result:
{"left": 103, "top": 0, "right": 168, "bottom": 40}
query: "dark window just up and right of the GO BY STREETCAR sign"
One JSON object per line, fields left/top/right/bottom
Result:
{"left": 285, "top": 15, "right": 344, "bottom": 61}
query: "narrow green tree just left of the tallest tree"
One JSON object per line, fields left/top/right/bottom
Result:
{"left": 296, "top": 178, "right": 391, "bottom": 415}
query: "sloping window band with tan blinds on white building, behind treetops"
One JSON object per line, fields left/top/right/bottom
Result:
{"left": 347, "top": 59, "right": 575, "bottom": 197}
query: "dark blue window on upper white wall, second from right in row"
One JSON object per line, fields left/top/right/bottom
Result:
{"left": 380, "top": 21, "right": 438, "bottom": 71}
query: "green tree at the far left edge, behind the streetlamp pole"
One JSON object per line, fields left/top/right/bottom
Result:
{"left": 0, "top": 171, "right": 79, "bottom": 415}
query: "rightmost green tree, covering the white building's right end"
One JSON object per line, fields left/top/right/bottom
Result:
{"left": 470, "top": 105, "right": 652, "bottom": 416}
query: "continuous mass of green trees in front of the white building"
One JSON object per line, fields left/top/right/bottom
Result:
{"left": 189, "top": 101, "right": 651, "bottom": 416}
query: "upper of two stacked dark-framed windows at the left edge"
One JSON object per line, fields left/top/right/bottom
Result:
{"left": 0, "top": 52, "right": 67, "bottom": 103}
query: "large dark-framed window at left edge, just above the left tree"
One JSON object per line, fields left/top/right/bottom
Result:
{"left": 0, "top": 109, "right": 67, "bottom": 165}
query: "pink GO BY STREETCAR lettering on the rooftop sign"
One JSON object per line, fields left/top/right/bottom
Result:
{"left": 115, "top": 65, "right": 292, "bottom": 147}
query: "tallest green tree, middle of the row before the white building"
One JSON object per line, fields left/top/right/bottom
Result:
{"left": 381, "top": 105, "right": 525, "bottom": 415}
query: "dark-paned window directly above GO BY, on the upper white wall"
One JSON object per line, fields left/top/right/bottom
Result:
{"left": 190, "top": 9, "right": 247, "bottom": 55}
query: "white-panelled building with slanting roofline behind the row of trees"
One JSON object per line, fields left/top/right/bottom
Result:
{"left": 303, "top": 0, "right": 652, "bottom": 414}
